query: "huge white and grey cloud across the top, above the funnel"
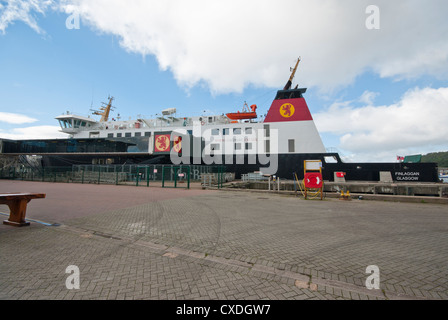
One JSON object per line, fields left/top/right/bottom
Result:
{"left": 0, "top": 0, "right": 448, "bottom": 93}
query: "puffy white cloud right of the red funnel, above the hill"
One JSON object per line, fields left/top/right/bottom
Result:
{"left": 314, "top": 88, "right": 448, "bottom": 160}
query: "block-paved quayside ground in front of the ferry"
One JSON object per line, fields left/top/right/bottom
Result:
{"left": 0, "top": 180, "right": 448, "bottom": 300}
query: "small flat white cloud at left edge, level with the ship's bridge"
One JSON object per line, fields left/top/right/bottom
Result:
{"left": 0, "top": 126, "right": 68, "bottom": 140}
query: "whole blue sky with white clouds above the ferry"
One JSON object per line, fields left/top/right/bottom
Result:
{"left": 0, "top": 0, "right": 448, "bottom": 161}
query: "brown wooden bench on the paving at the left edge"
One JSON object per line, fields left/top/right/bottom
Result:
{"left": 0, "top": 193, "right": 45, "bottom": 227}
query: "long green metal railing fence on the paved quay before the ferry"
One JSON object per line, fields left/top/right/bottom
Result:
{"left": 0, "top": 165, "right": 226, "bottom": 189}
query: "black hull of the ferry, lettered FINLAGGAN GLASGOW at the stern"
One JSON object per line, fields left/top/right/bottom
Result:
{"left": 37, "top": 153, "right": 439, "bottom": 182}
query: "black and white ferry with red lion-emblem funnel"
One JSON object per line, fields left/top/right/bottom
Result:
{"left": 0, "top": 58, "right": 439, "bottom": 182}
